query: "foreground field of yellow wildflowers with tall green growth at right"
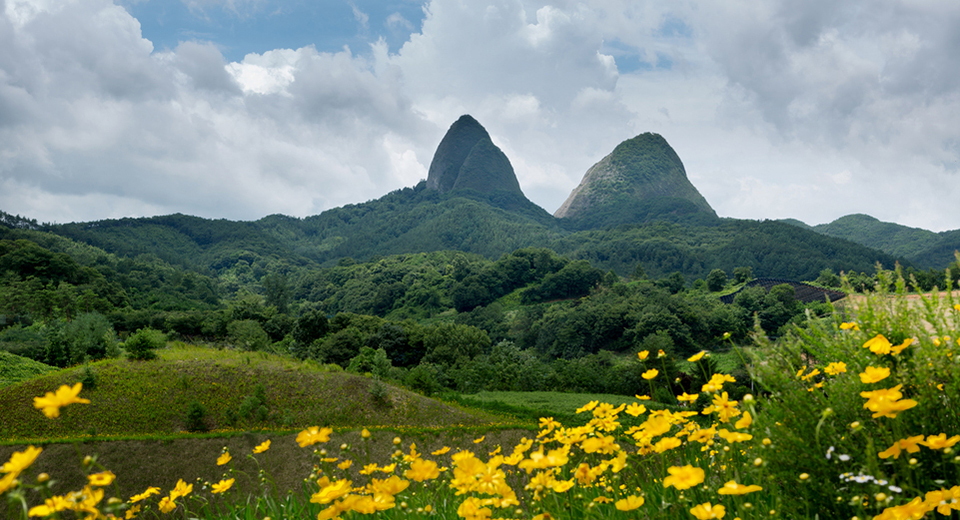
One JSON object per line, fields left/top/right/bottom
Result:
{"left": 0, "top": 273, "right": 960, "bottom": 520}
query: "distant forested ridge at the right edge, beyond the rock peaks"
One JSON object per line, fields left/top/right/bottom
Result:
{"left": 783, "top": 213, "right": 960, "bottom": 269}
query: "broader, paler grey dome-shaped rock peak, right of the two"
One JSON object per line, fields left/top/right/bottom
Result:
{"left": 554, "top": 133, "right": 716, "bottom": 219}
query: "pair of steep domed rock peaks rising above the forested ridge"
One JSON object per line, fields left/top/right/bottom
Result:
{"left": 427, "top": 115, "right": 716, "bottom": 224}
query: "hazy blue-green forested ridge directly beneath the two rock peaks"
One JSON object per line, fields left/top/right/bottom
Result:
{"left": 31, "top": 193, "right": 909, "bottom": 286}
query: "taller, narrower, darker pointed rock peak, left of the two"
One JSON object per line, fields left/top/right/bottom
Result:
{"left": 427, "top": 115, "right": 523, "bottom": 196}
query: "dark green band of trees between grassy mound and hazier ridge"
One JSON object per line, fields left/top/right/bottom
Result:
{"left": 0, "top": 231, "right": 824, "bottom": 394}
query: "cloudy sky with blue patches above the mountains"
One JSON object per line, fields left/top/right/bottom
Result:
{"left": 0, "top": 0, "right": 960, "bottom": 231}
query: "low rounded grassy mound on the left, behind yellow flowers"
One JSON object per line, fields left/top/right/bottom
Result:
{"left": 0, "top": 344, "right": 510, "bottom": 442}
